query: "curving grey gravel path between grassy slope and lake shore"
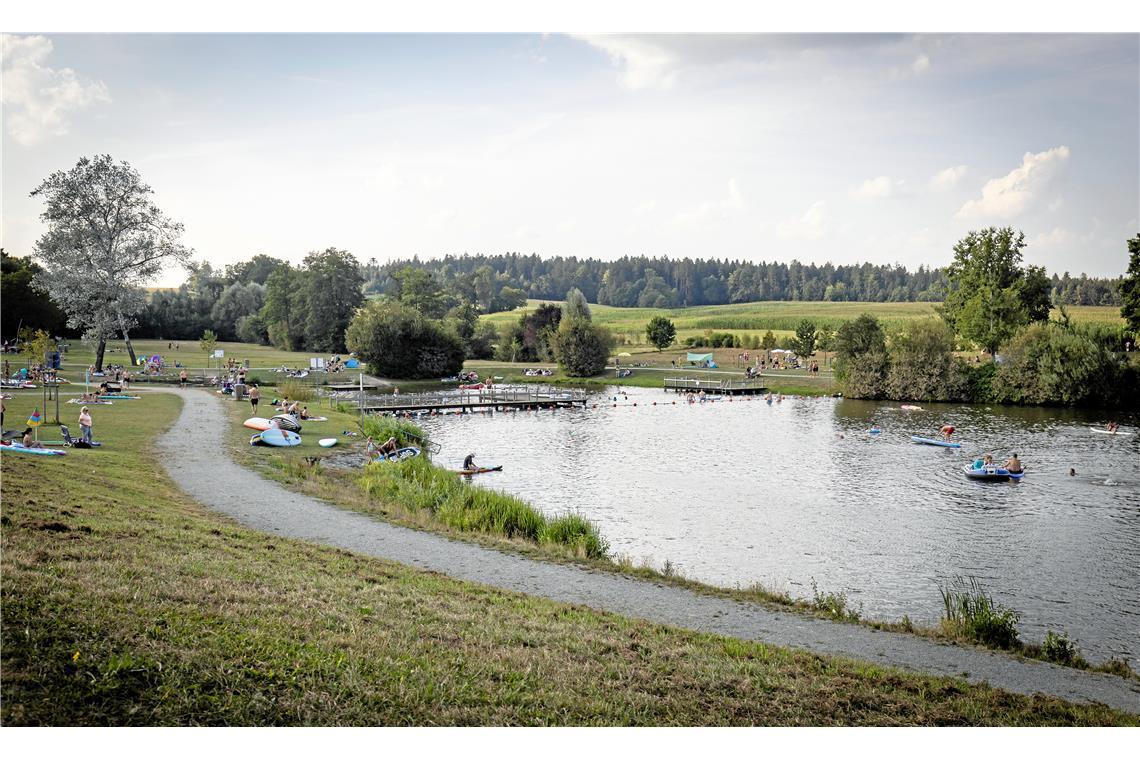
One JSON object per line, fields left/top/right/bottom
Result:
{"left": 161, "top": 390, "right": 1140, "bottom": 713}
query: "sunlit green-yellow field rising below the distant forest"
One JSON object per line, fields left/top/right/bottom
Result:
{"left": 482, "top": 300, "right": 1123, "bottom": 346}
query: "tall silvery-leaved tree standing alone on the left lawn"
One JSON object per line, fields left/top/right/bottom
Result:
{"left": 32, "top": 155, "right": 190, "bottom": 369}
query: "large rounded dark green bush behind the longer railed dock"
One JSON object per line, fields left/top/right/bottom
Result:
{"left": 345, "top": 301, "right": 465, "bottom": 379}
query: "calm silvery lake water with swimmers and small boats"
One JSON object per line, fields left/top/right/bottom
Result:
{"left": 420, "top": 389, "right": 1140, "bottom": 662}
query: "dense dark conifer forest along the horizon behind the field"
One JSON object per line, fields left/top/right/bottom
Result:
{"left": 361, "top": 253, "right": 1121, "bottom": 312}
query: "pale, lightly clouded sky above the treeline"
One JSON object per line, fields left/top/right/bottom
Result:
{"left": 2, "top": 34, "right": 1140, "bottom": 285}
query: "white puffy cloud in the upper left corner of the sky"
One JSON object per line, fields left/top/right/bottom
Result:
{"left": 0, "top": 34, "right": 111, "bottom": 146}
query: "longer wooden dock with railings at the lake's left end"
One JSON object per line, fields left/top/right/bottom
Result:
{"left": 360, "top": 385, "right": 586, "bottom": 414}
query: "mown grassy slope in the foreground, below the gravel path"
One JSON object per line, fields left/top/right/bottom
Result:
{"left": 0, "top": 393, "right": 1138, "bottom": 726}
